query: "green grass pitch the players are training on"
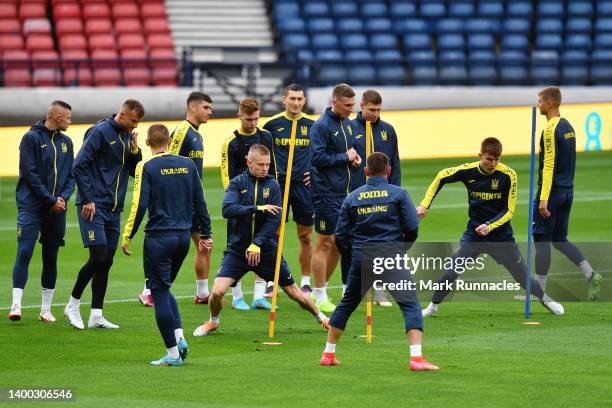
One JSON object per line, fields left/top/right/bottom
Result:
{"left": 0, "top": 152, "right": 612, "bottom": 408}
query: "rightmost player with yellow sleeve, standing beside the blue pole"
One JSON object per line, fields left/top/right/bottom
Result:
{"left": 533, "top": 87, "right": 602, "bottom": 301}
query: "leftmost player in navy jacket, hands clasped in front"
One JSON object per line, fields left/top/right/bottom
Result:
{"left": 9, "top": 101, "right": 74, "bottom": 323}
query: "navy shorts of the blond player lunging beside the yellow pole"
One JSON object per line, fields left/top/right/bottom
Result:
{"left": 216, "top": 251, "right": 295, "bottom": 287}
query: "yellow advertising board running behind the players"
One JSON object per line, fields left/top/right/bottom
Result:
{"left": 0, "top": 103, "right": 612, "bottom": 176}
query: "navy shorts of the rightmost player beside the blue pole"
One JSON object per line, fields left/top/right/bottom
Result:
{"left": 533, "top": 190, "right": 574, "bottom": 242}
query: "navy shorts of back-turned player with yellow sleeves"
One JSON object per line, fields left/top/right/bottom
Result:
{"left": 143, "top": 233, "right": 191, "bottom": 289}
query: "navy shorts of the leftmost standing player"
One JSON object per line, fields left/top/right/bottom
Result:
{"left": 17, "top": 208, "right": 66, "bottom": 246}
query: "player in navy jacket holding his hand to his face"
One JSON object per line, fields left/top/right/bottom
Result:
{"left": 64, "top": 99, "right": 145, "bottom": 329}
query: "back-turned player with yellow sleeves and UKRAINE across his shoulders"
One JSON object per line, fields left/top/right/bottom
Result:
{"left": 121, "top": 125, "right": 212, "bottom": 365}
